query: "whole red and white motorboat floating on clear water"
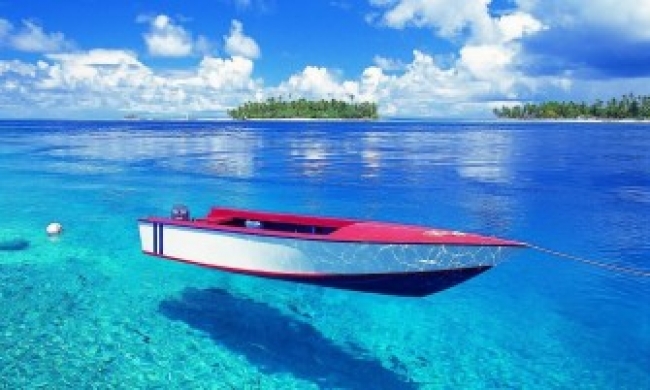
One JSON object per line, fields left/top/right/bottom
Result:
{"left": 138, "top": 205, "right": 525, "bottom": 297}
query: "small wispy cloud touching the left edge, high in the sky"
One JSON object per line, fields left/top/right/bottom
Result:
{"left": 0, "top": 19, "right": 74, "bottom": 53}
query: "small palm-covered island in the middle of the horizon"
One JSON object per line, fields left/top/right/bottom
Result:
{"left": 227, "top": 97, "right": 379, "bottom": 119}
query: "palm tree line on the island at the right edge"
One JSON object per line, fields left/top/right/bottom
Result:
{"left": 492, "top": 93, "right": 650, "bottom": 120}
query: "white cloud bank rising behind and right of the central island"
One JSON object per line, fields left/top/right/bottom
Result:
{"left": 266, "top": 45, "right": 565, "bottom": 117}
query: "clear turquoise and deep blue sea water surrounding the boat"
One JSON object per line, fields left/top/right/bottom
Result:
{"left": 0, "top": 121, "right": 650, "bottom": 389}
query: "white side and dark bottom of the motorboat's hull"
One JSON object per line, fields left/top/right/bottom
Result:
{"left": 139, "top": 220, "right": 511, "bottom": 296}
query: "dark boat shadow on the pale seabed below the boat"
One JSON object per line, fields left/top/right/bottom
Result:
{"left": 159, "top": 288, "right": 417, "bottom": 390}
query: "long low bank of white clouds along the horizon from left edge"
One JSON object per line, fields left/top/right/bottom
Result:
{"left": 0, "top": 44, "right": 540, "bottom": 117}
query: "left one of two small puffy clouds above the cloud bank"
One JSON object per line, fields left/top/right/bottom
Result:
{"left": 138, "top": 15, "right": 193, "bottom": 57}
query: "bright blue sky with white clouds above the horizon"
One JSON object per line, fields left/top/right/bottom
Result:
{"left": 0, "top": 0, "right": 650, "bottom": 119}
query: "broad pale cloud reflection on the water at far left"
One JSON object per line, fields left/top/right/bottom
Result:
{"left": 27, "top": 126, "right": 258, "bottom": 178}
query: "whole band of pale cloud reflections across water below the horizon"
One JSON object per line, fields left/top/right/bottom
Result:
{"left": 25, "top": 123, "right": 514, "bottom": 190}
